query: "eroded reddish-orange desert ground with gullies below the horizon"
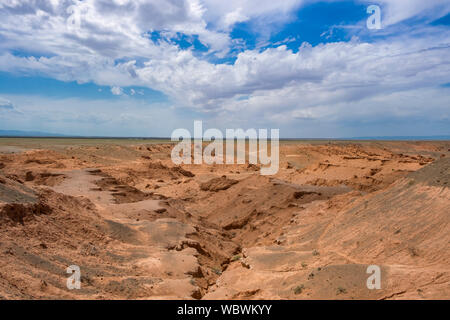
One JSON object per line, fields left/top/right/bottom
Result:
{"left": 0, "top": 138, "right": 450, "bottom": 299}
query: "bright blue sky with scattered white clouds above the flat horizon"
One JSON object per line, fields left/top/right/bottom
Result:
{"left": 0, "top": 0, "right": 450, "bottom": 138}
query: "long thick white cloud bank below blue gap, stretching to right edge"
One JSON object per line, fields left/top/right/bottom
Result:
{"left": 138, "top": 32, "right": 450, "bottom": 112}
